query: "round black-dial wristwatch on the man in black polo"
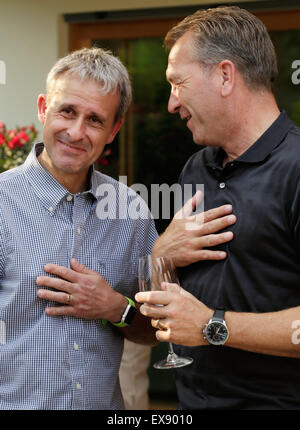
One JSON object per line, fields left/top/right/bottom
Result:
{"left": 203, "top": 308, "right": 229, "bottom": 345}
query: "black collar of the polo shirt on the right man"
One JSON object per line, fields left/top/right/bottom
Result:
{"left": 207, "top": 111, "right": 295, "bottom": 166}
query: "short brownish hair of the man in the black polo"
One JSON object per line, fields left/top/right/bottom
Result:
{"left": 165, "top": 6, "right": 278, "bottom": 91}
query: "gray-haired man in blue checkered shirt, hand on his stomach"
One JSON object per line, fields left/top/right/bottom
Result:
{"left": 0, "top": 48, "right": 234, "bottom": 410}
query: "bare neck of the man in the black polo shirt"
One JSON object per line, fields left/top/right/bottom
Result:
{"left": 222, "top": 91, "right": 280, "bottom": 162}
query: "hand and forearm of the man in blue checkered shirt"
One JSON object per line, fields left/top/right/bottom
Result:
{"left": 36, "top": 259, "right": 157, "bottom": 344}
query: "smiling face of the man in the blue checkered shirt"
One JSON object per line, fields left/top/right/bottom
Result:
{"left": 38, "top": 75, "right": 123, "bottom": 192}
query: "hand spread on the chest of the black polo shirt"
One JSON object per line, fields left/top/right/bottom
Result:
{"left": 152, "top": 191, "right": 236, "bottom": 267}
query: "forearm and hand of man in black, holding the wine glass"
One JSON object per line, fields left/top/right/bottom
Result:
{"left": 135, "top": 283, "right": 300, "bottom": 358}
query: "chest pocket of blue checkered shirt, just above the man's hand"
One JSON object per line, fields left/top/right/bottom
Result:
{"left": 96, "top": 258, "right": 138, "bottom": 297}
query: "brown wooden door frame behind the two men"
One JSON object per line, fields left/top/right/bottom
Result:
{"left": 69, "top": 7, "right": 300, "bottom": 181}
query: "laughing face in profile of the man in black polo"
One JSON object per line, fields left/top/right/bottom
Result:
{"left": 166, "top": 33, "right": 223, "bottom": 146}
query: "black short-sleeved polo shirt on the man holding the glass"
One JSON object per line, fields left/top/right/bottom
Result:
{"left": 175, "top": 112, "right": 300, "bottom": 409}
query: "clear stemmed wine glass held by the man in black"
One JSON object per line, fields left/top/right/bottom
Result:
{"left": 139, "top": 255, "right": 193, "bottom": 369}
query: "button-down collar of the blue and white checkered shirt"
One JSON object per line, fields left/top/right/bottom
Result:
{"left": 24, "top": 143, "right": 97, "bottom": 213}
